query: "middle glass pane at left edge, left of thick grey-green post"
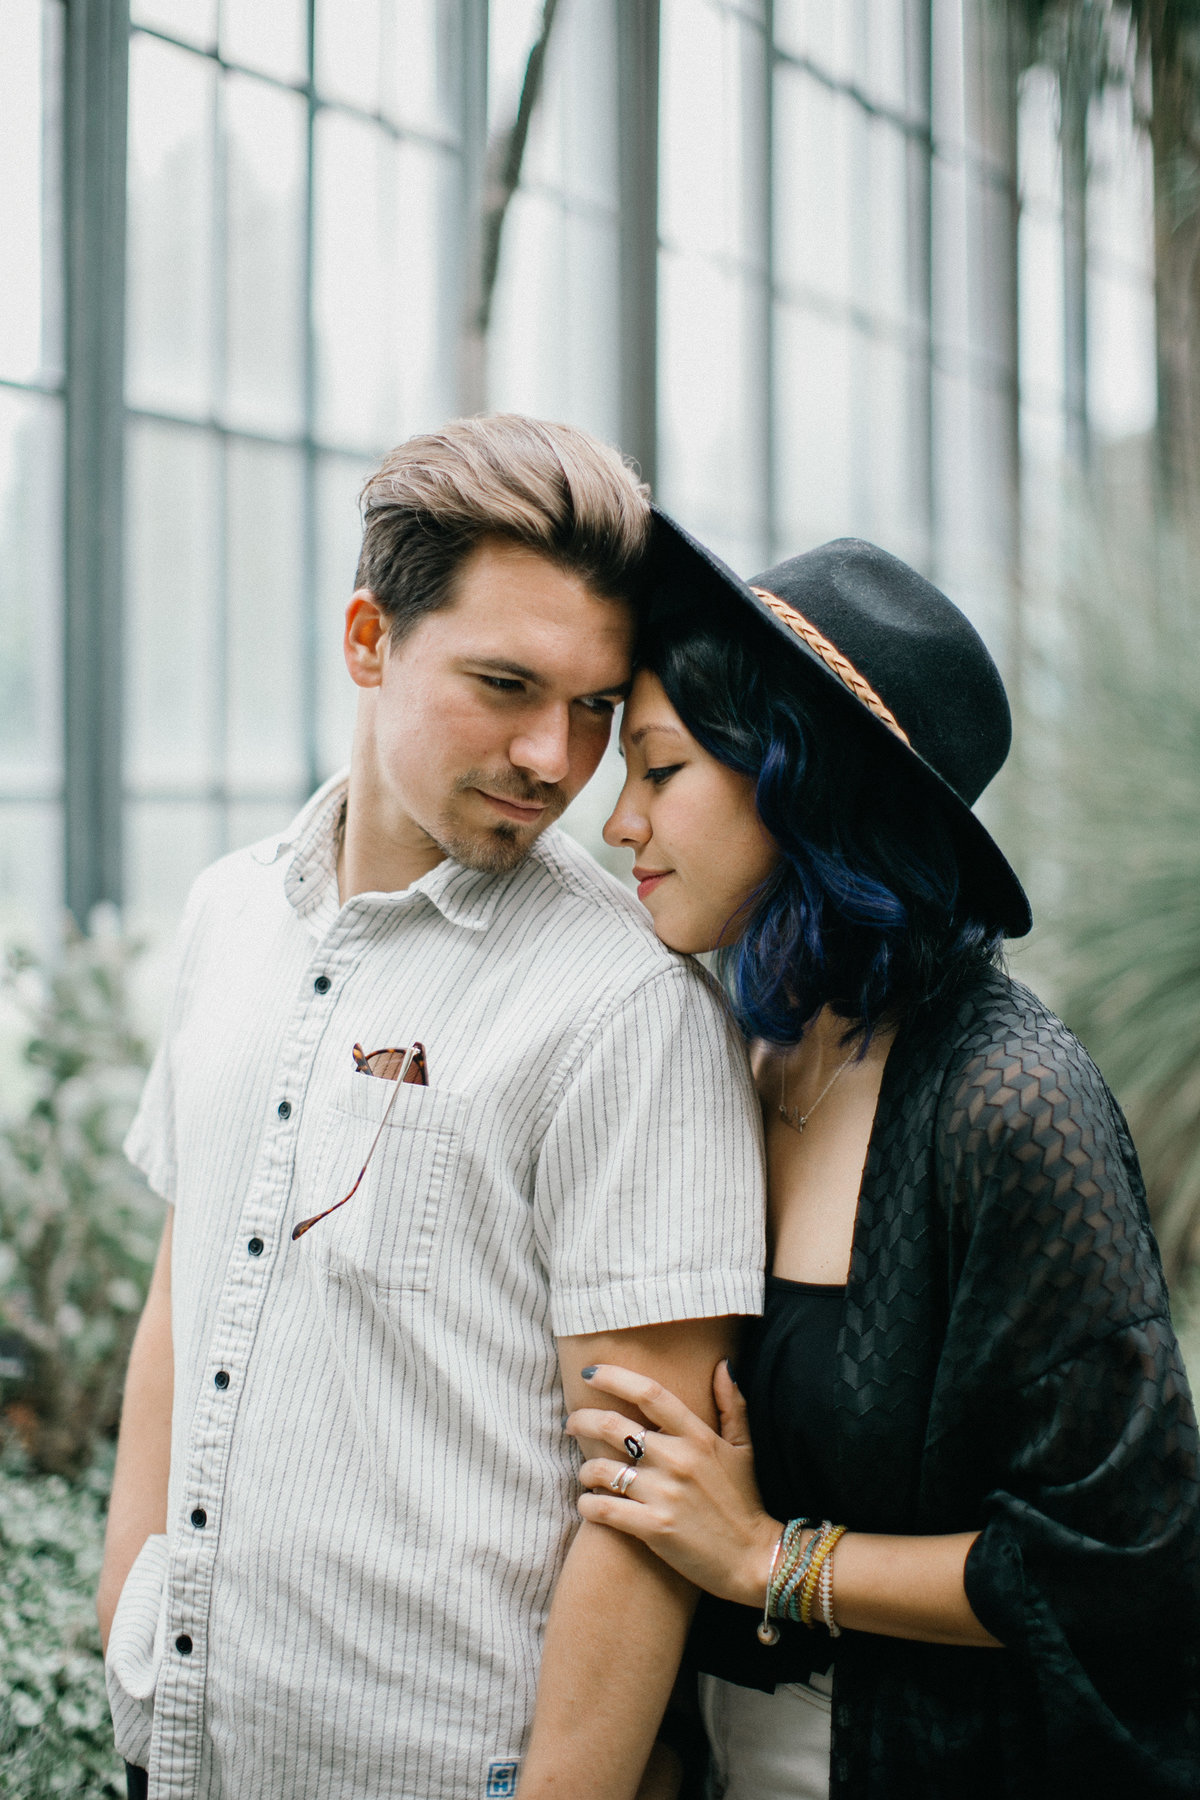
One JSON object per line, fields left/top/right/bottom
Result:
{"left": 0, "top": 389, "right": 63, "bottom": 794}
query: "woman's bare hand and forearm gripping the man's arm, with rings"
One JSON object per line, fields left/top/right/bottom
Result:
{"left": 567, "top": 1364, "right": 997, "bottom": 1647}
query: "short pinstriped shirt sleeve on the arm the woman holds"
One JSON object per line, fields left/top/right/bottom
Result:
{"left": 534, "top": 963, "right": 766, "bottom": 1337}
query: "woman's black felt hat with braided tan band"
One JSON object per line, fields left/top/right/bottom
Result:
{"left": 646, "top": 508, "right": 1033, "bottom": 938}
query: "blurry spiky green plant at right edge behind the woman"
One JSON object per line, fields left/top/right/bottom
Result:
{"left": 1027, "top": 527, "right": 1200, "bottom": 1278}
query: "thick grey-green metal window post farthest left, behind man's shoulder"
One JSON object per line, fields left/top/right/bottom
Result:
{"left": 63, "top": 0, "right": 130, "bottom": 923}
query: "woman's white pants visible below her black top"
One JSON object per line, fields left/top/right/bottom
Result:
{"left": 700, "top": 1676, "right": 833, "bottom": 1800}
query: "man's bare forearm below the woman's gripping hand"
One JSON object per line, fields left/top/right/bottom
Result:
{"left": 520, "top": 1525, "right": 696, "bottom": 1800}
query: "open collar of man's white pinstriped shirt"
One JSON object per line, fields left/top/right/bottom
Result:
{"left": 268, "top": 769, "right": 511, "bottom": 931}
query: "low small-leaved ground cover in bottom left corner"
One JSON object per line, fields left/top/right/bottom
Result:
{"left": 0, "top": 1449, "right": 124, "bottom": 1800}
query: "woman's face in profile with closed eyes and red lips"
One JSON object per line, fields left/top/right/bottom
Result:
{"left": 604, "top": 670, "right": 779, "bottom": 950}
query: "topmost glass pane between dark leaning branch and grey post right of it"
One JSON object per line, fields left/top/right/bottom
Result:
{"left": 522, "top": 0, "right": 618, "bottom": 209}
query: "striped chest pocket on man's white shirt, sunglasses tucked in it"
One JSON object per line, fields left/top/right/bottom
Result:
{"left": 308, "top": 1075, "right": 466, "bottom": 1292}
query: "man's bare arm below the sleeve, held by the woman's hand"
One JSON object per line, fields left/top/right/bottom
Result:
{"left": 520, "top": 1319, "right": 738, "bottom": 1800}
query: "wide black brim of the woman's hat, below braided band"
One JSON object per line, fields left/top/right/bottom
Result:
{"left": 644, "top": 506, "right": 1033, "bottom": 938}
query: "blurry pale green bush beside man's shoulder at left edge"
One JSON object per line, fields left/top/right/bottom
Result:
{"left": 0, "top": 932, "right": 162, "bottom": 1476}
